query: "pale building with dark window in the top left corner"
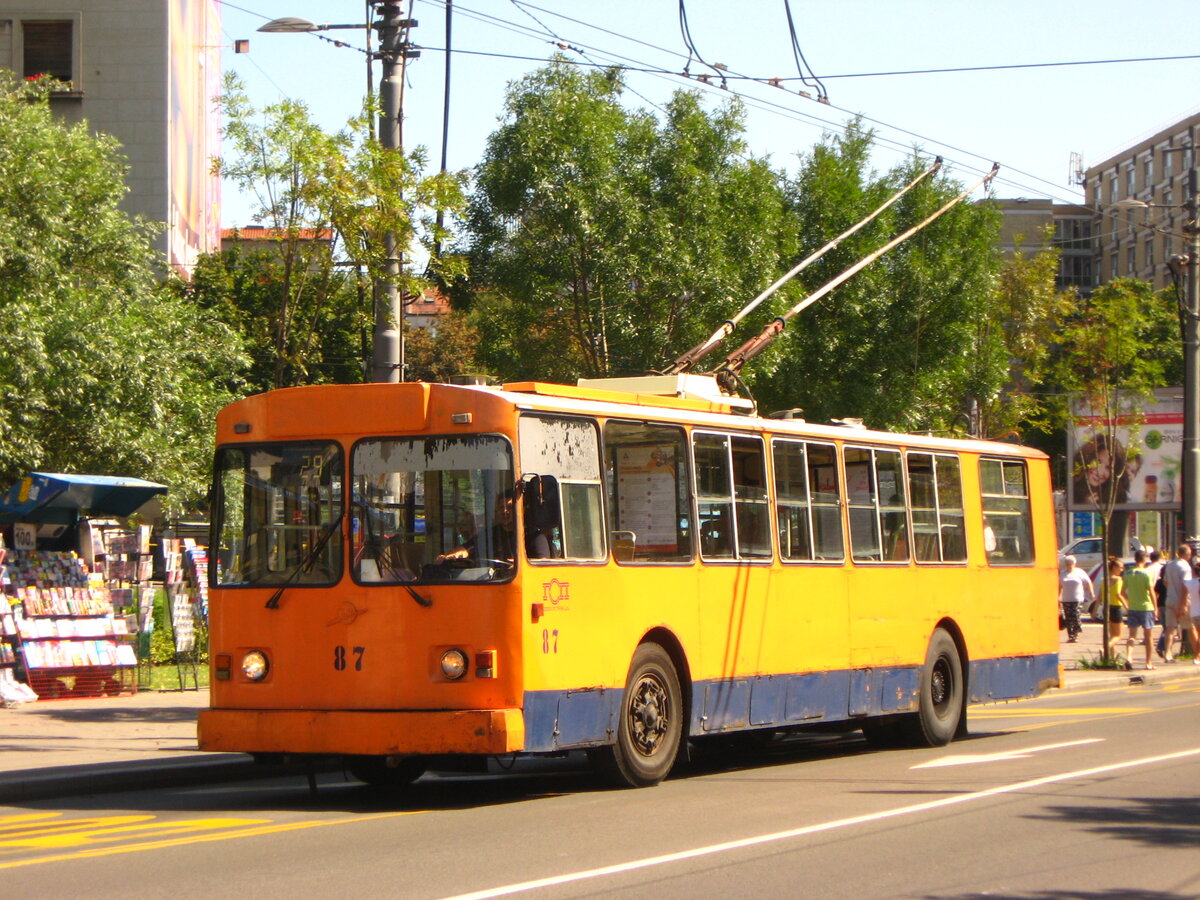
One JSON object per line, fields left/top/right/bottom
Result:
{"left": 0, "top": 0, "right": 221, "bottom": 276}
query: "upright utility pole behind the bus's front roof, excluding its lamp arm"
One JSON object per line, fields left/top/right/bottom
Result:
{"left": 371, "top": 0, "right": 404, "bottom": 383}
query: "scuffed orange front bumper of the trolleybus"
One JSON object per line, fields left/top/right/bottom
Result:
{"left": 198, "top": 709, "right": 524, "bottom": 756}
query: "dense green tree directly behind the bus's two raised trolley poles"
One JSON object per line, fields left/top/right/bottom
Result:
{"left": 746, "top": 124, "right": 1007, "bottom": 430}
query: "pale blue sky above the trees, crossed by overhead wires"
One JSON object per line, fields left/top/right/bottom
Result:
{"left": 218, "top": 0, "right": 1200, "bottom": 227}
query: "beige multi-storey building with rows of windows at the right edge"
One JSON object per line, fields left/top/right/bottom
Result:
{"left": 1085, "top": 113, "right": 1200, "bottom": 289}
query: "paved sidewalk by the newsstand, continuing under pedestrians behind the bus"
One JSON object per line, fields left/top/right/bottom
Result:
{"left": 0, "top": 623, "right": 1200, "bottom": 803}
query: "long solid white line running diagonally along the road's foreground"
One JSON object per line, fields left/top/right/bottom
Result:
{"left": 445, "top": 749, "right": 1200, "bottom": 900}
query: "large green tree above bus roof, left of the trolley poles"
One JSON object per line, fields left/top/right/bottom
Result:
{"left": 458, "top": 59, "right": 784, "bottom": 380}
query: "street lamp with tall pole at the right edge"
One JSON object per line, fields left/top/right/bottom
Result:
{"left": 1112, "top": 165, "right": 1200, "bottom": 553}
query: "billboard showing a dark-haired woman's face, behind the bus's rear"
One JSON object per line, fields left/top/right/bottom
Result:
{"left": 1067, "top": 388, "right": 1183, "bottom": 511}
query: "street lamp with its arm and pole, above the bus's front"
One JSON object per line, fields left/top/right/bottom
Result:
{"left": 258, "top": 0, "right": 421, "bottom": 383}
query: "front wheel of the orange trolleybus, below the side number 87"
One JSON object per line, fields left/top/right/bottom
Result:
{"left": 588, "top": 643, "right": 683, "bottom": 787}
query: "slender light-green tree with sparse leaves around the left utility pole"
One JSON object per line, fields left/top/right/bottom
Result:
{"left": 210, "top": 76, "right": 463, "bottom": 388}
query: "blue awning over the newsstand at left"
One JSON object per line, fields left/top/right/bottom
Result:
{"left": 0, "top": 472, "right": 167, "bottom": 522}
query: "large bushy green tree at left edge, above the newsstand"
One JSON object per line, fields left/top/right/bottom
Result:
{"left": 0, "top": 72, "right": 245, "bottom": 510}
